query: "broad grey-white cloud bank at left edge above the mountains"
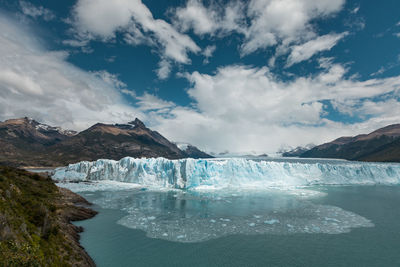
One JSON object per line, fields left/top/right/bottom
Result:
{"left": 0, "top": 15, "right": 143, "bottom": 130}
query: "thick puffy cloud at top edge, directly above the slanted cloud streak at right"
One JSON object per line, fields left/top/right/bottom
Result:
{"left": 242, "top": 0, "right": 344, "bottom": 54}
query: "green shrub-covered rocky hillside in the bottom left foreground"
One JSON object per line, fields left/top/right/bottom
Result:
{"left": 0, "top": 166, "right": 96, "bottom": 266}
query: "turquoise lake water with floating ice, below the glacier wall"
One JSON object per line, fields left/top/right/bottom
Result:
{"left": 72, "top": 186, "right": 400, "bottom": 267}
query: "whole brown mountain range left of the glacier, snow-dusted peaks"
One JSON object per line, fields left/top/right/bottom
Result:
{"left": 0, "top": 117, "right": 211, "bottom": 166}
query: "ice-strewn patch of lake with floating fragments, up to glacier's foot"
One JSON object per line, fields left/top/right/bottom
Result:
{"left": 83, "top": 189, "right": 374, "bottom": 242}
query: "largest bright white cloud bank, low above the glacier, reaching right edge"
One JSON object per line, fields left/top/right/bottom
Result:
{"left": 149, "top": 63, "right": 400, "bottom": 153}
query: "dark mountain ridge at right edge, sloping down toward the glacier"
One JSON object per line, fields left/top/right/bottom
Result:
{"left": 282, "top": 124, "right": 400, "bottom": 162}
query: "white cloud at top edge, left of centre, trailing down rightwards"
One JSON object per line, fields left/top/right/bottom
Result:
{"left": 73, "top": 0, "right": 200, "bottom": 64}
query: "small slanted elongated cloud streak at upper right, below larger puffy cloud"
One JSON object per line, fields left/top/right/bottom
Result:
{"left": 286, "top": 32, "right": 348, "bottom": 67}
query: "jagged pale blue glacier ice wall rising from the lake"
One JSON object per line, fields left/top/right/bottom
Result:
{"left": 53, "top": 157, "right": 400, "bottom": 189}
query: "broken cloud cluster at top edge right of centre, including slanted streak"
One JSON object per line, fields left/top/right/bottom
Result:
{"left": 173, "top": 0, "right": 344, "bottom": 65}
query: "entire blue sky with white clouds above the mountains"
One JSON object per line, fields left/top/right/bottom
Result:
{"left": 0, "top": 0, "right": 400, "bottom": 154}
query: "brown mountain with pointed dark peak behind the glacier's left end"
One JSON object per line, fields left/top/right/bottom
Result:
{"left": 49, "top": 119, "right": 184, "bottom": 164}
